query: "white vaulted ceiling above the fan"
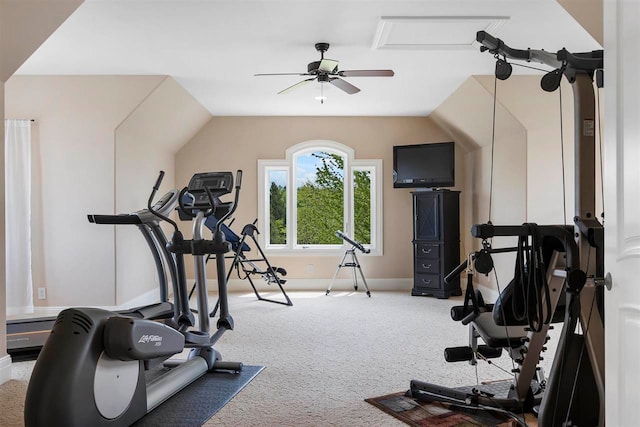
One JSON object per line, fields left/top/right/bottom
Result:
{"left": 17, "top": 0, "right": 600, "bottom": 116}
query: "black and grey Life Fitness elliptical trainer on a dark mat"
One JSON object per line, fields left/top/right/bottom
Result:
{"left": 24, "top": 171, "right": 242, "bottom": 427}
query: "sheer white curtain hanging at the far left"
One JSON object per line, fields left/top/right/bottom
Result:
{"left": 4, "top": 120, "right": 33, "bottom": 314}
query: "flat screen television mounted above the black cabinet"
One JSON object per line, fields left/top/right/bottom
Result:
{"left": 393, "top": 142, "right": 455, "bottom": 188}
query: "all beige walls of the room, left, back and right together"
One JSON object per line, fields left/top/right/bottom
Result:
{"left": 1, "top": 76, "right": 596, "bottom": 306}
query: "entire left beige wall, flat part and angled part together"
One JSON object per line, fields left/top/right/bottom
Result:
{"left": 6, "top": 76, "right": 211, "bottom": 307}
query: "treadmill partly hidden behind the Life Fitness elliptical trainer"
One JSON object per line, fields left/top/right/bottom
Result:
{"left": 7, "top": 190, "right": 182, "bottom": 361}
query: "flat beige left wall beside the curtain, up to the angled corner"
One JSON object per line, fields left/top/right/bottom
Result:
{"left": 5, "top": 76, "right": 162, "bottom": 306}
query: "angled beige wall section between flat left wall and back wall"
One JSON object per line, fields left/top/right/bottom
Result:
{"left": 115, "top": 77, "right": 211, "bottom": 305}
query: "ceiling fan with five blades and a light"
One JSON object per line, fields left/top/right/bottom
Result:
{"left": 254, "top": 43, "right": 394, "bottom": 95}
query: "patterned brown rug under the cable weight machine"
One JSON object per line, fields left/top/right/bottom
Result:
{"left": 365, "top": 392, "right": 537, "bottom": 427}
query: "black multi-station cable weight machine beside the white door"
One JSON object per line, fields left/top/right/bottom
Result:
{"left": 408, "top": 31, "right": 605, "bottom": 427}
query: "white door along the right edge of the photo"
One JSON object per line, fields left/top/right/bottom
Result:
{"left": 603, "top": 0, "right": 640, "bottom": 427}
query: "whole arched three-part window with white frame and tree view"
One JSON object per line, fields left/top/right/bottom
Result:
{"left": 258, "top": 141, "right": 382, "bottom": 255}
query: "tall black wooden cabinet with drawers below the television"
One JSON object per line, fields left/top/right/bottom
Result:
{"left": 411, "top": 190, "right": 462, "bottom": 298}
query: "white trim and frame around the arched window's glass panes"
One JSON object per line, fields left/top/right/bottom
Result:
{"left": 258, "top": 140, "right": 384, "bottom": 256}
